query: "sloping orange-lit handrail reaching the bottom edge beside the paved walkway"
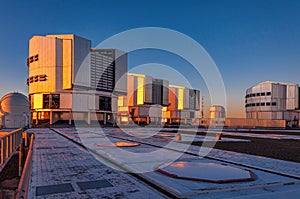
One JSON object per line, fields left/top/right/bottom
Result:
{"left": 15, "top": 134, "right": 34, "bottom": 199}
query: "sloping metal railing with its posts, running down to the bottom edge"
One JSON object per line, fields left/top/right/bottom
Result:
{"left": 15, "top": 133, "right": 34, "bottom": 199}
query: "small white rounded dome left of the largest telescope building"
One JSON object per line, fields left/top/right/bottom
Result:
{"left": 0, "top": 93, "right": 30, "bottom": 114}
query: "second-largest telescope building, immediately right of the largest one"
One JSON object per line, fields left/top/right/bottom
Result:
{"left": 118, "top": 73, "right": 169, "bottom": 125}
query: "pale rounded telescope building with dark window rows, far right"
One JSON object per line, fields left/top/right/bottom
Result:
{"left": 245, "top": 81, "right": 300, "bottom": 125}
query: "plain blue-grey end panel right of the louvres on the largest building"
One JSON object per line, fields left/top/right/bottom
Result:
{"left": 114, "top": 50, "right": 128, "bottom": 94}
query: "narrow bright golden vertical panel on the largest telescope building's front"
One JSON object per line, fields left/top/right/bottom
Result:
{"left": 62, "top": 39, "right": 73, "bottom": 89}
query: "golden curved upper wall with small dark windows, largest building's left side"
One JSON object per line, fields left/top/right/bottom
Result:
{"left": 28, "top": 36, "right": 62, "bottom": 94}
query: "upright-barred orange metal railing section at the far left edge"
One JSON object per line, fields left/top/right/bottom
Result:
{"left": 0, "top": 128, "right": 23, "bottom": 171}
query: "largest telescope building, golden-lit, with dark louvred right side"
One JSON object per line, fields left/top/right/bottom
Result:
{"left": 27, "top": 34, "right": 127, "bottom": 125}
